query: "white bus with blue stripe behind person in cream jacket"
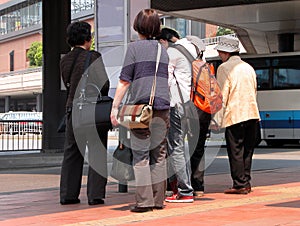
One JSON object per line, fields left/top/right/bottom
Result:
{"left": 207, "top": 52, "right": 300, "bottom": 146}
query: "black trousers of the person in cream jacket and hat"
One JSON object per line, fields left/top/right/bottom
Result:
{"left": 225, "top": 119, "right": 258, "bottom": 189}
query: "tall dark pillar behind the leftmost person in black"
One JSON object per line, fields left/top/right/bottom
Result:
{"left": 42, "top": 0, "right": 71, "bottom": 152}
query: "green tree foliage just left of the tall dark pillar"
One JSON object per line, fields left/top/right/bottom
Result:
{"left": 27, "top": 41, "right": 43, "bottom": 67}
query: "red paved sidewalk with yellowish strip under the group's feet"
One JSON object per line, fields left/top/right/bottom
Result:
{"left": 0, "top": 167, "right": 300, "bottom": 226}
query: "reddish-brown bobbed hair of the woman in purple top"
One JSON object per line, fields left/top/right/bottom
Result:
{"left": 133, "top": 9, "right": 160, "bottom": 39}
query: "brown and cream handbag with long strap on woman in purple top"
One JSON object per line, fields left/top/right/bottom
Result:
{"left": 118, "top": 43, "right": 161, "bottom": 129}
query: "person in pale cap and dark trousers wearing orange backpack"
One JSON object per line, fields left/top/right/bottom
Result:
{"left": 174, "top": 36, "right": 223, "bottom": 197}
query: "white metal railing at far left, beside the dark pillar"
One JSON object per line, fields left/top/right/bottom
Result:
{"left": 0, "top": 120, "right": 43, "bottom": 152}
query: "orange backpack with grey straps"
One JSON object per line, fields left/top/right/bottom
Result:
{"left": 172, "top": 45, "right": 223, "bottom": 114}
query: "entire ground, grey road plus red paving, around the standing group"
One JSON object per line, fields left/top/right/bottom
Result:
{"left": 0, "top": 147, "right": 300, "bottom": 226}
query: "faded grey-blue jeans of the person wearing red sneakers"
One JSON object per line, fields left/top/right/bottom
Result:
{"left": 168, "top": 107, "right": 193, "bottom": 196}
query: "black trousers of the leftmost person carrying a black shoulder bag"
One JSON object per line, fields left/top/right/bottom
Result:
{"left": 60, "top": 112, "right": 107, "bottom": 200}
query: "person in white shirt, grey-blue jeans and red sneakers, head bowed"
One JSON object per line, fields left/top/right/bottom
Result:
{"left": 157, "top": 28, "right": 197, "bottom": 203}
